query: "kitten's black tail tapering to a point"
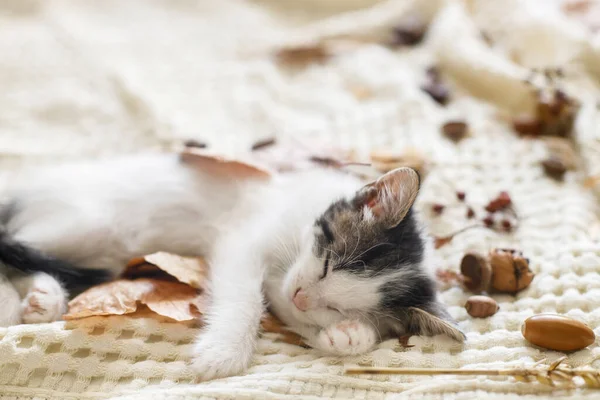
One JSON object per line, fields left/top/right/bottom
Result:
{"left": 0, "top": 228, "right": 111, "bottom": 288}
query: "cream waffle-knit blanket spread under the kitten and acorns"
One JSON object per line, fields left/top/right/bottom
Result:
{"left": 0, "top": 0, "right": 600, "bottom": 399}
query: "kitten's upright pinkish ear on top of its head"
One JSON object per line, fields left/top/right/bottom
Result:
{"left": 352, "top": 168, "right": 419, "bottom": 228}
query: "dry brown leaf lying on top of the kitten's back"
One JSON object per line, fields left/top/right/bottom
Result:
{"left": 180, "top": 147, "right": 272, "bottom": 179}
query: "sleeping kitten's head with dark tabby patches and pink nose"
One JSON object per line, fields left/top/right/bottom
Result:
{"left": 283, "top": 168, "right": 464, "bottom": 340}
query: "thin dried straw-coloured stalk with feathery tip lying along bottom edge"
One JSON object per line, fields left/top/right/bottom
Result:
{"left": 344, "top": 357, "right": 600, "bottom": 389}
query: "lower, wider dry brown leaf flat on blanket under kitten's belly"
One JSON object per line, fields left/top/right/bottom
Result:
{"left": 63, "top": 278, "right": 205, "bottom": 321}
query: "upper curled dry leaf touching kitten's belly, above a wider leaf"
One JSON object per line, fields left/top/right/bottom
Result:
{"left": 123, "top": 251, "right": 208, "bottom": 289}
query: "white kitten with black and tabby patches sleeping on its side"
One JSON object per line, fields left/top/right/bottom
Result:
{"left": 0, "top": 155, "right": 464, "bottom": 379}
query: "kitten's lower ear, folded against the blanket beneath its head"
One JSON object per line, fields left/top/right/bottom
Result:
{"left": 405, "top": 302, "right": 467, "bottom": 342}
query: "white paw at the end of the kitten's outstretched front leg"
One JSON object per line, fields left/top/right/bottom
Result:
{"left": 192, "top": 333, "right": 254, "bottom": 381}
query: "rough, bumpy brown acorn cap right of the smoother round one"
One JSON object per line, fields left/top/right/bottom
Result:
{"left": 489, "top": 249, "right": 535, "bottom": 293}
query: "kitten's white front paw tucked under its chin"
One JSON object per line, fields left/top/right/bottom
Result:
{"left": 313, "top": 320, "right": 377, "bottom": 356}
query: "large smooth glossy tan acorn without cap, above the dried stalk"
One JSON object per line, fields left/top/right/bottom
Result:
{"left": 521, "top": 314, "right": 596, "bottom": 351}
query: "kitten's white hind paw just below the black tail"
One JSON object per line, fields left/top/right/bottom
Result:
{"left": 21, "top": 280, "right": 67, "bottom": 324}
